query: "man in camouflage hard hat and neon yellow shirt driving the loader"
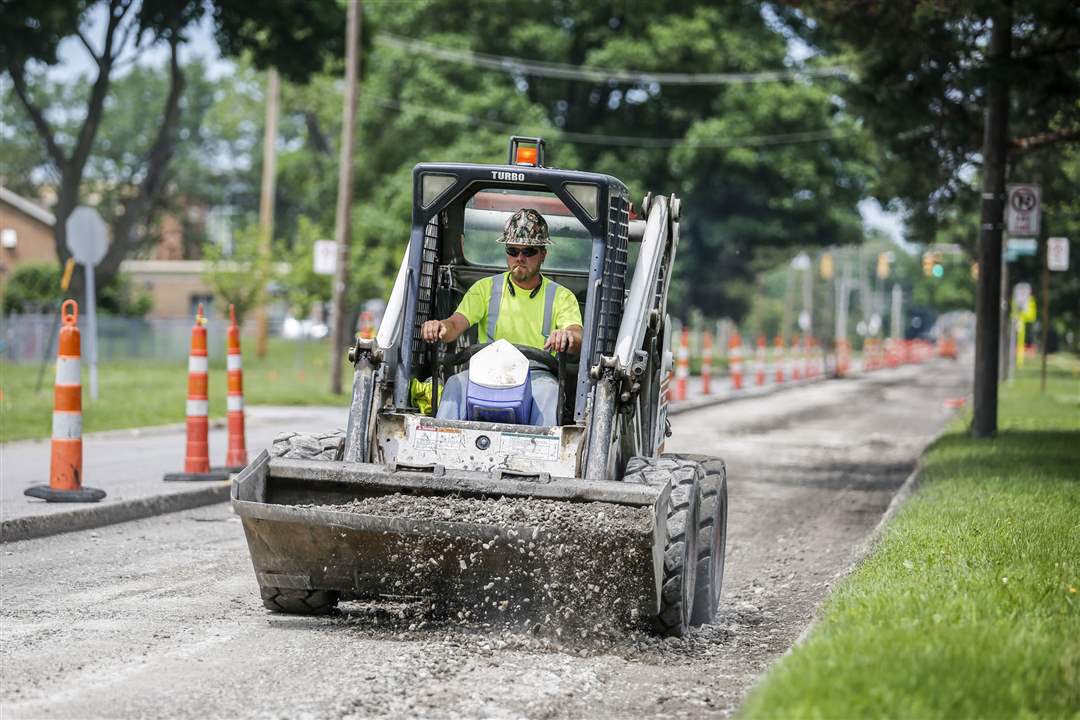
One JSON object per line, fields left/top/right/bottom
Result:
{"left": 420, "top": 207, "right": 581, "bottom": 425}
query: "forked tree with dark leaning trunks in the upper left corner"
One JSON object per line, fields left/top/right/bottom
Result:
{"left": 0, "top": 0, "right": 342, "bottom": 297}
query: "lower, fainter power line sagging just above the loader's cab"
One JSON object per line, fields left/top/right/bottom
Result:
{"left": 366, "top": 96, "right": 850, "bottom": 148}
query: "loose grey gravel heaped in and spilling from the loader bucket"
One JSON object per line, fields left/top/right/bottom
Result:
{"left": 311, "top": 493, "right": 654, "bottom": 638}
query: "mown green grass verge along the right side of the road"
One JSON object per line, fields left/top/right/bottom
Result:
{"left": 742, "top": 356, "right": 1080, "bottom": 718}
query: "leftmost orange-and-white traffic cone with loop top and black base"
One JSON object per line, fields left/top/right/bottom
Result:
{"left": 23, "top": 300, "right": 105, "bottom": 503}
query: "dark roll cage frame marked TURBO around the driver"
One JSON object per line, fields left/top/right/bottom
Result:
{"left": 378, "top": 163, "right": 631, "bottom": 423}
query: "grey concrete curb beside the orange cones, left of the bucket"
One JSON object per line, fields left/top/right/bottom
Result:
{"left": 0, "top": 483, "right": 231, "bottom": 543}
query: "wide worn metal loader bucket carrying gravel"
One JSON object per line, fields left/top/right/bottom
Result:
{"left": 232, "top": 452, "right": 671, "bottom": 629}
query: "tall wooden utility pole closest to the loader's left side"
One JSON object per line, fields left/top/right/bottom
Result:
{"left": 330, "top": 0, "right": 361, "bottom": 395}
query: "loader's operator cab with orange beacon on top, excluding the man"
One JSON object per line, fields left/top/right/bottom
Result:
{"left": 395, "top": 137, "right": 630, "bottom": 425}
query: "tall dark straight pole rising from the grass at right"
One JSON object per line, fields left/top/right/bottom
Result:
{"left": 971, "top": 2, "right": 1012, "bottom": 437}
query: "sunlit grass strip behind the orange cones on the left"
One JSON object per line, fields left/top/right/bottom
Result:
{"left": 0, "top": 338, "right": 352, "bottom": 441}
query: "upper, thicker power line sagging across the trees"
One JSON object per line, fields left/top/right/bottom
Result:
{"left": 375, "top": 32, "right": 851, "bottom": 85}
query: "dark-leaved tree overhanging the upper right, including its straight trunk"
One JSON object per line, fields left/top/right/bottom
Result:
{"left": 806, "top": 0, "right": 1080, "bottom": 437}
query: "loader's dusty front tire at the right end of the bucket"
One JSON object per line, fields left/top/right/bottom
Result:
{"left": 623, "top": 458, "right": 704, "bottom": 637}
